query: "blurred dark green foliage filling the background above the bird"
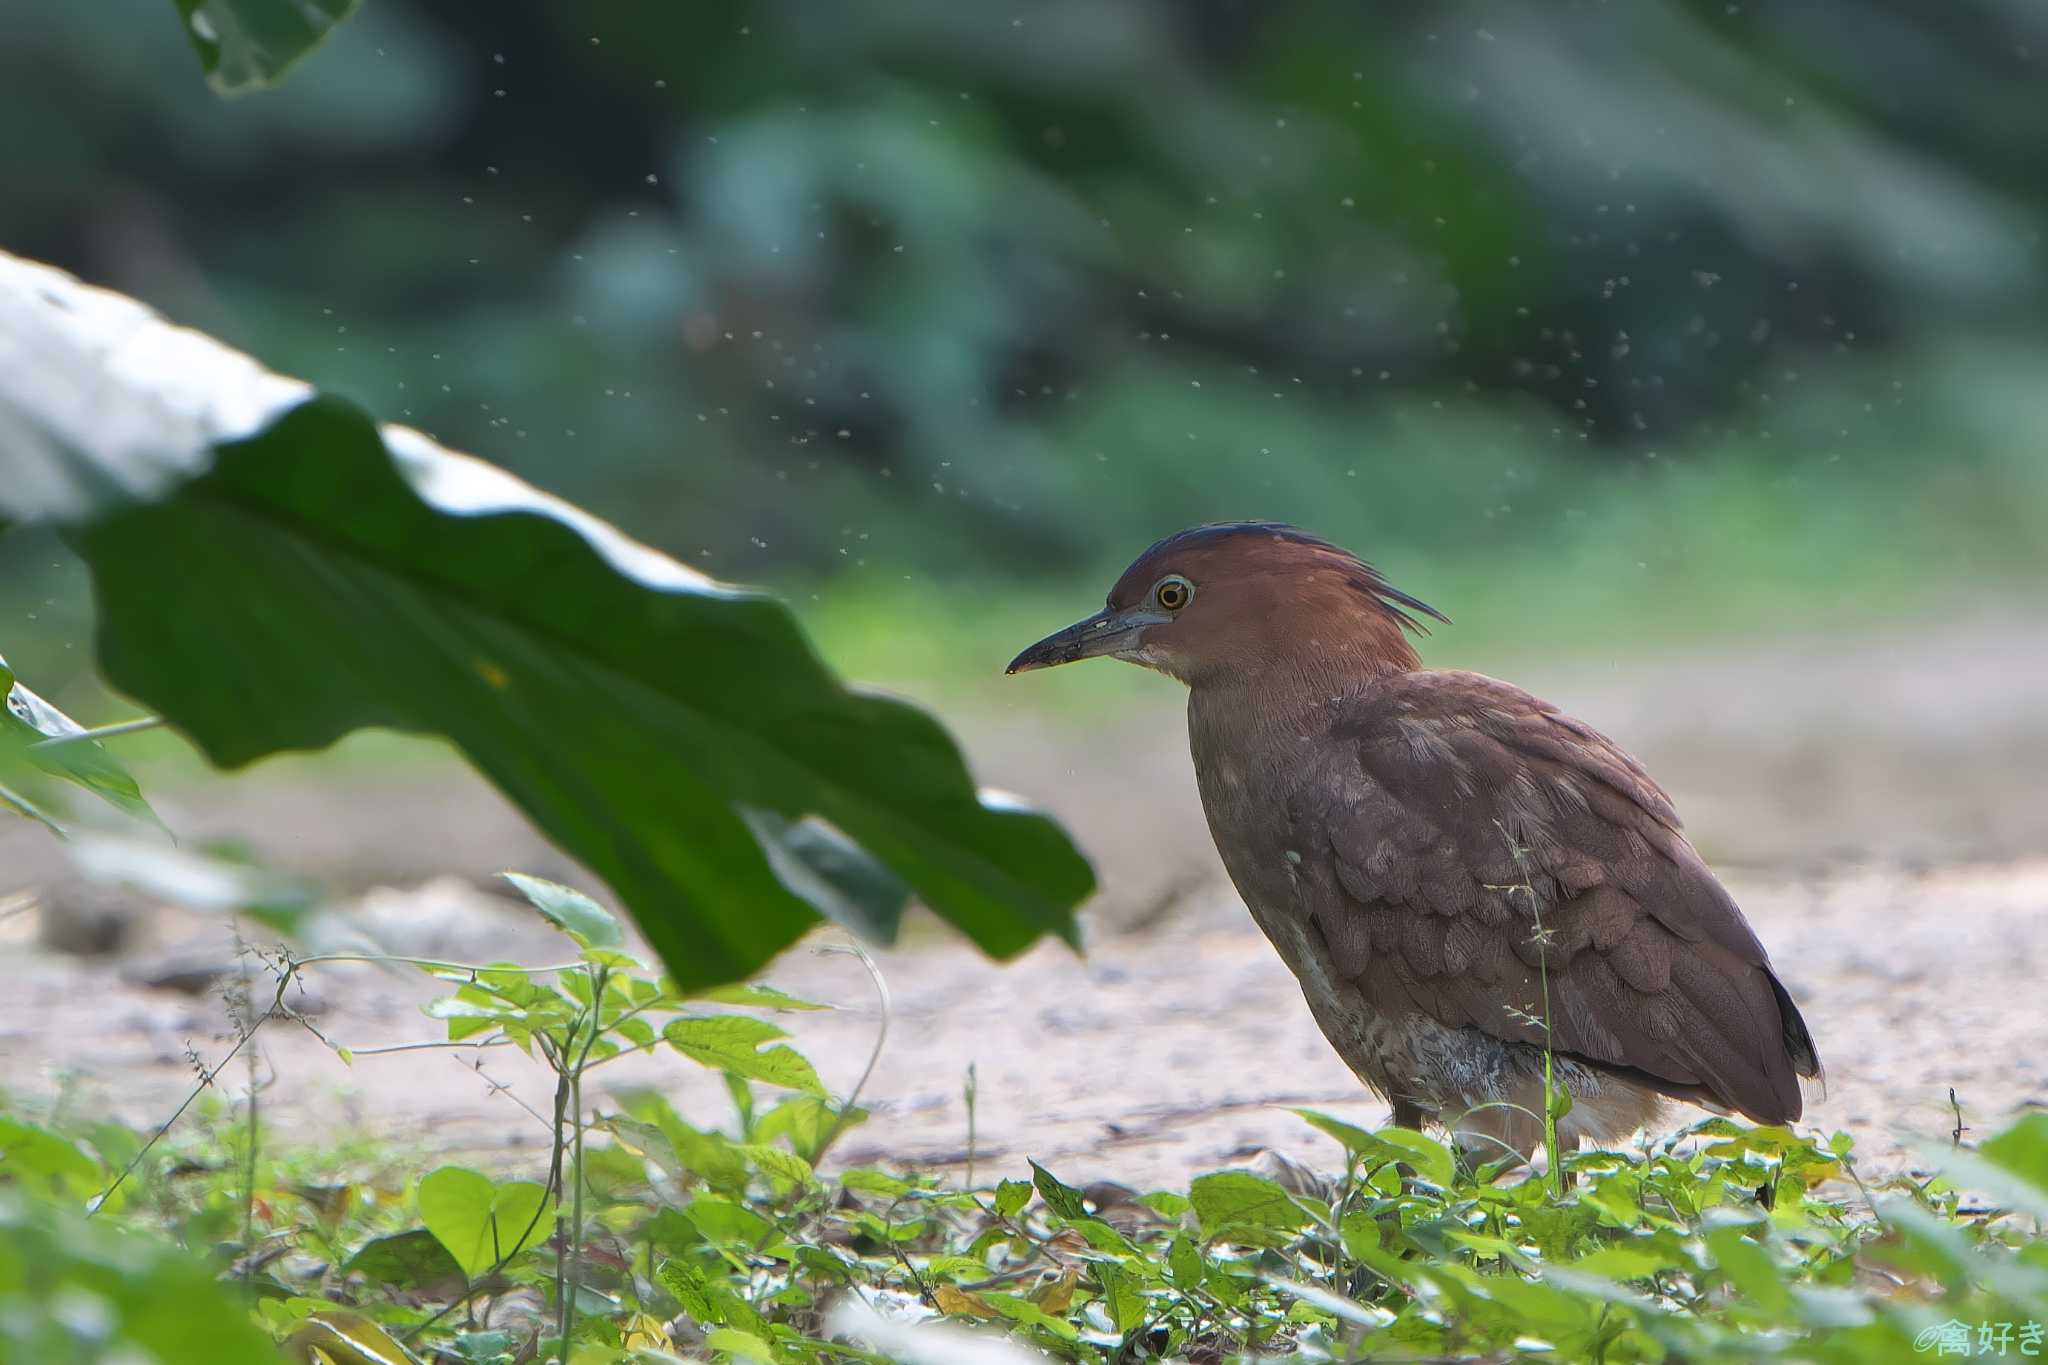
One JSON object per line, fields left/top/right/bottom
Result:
{"left": 0, "top": 0, "right": 2048, "bottom": 616}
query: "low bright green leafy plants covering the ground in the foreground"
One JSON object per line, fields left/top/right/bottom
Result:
{"left": 0, "top": 882, "right": 2048, "bottom": 1365}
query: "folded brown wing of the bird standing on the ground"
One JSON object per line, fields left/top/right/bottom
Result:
{"left": 1288, "top": 671, "right": 1819, "bottom": 1121}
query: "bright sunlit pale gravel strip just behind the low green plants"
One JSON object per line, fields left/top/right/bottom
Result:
{"left": 0, "top": 862, "right": 2048, "bottom": 1185}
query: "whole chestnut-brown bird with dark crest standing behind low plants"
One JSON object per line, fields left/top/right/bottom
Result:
{"left": 1010, "top": 522, "right": 1821, "bottom": 1152}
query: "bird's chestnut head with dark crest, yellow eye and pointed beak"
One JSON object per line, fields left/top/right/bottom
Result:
{"left": 1008, "top": 522, "right": 1448, "bottom": 686}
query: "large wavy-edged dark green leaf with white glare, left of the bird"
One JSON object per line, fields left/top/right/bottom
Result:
{"left": 0, "top": 256, "right": 1094, "bottom": 990}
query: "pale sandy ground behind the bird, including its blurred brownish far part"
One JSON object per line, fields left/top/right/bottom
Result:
{"left": 0, "top": 614, "right": 2048, "bottom": 1185}
